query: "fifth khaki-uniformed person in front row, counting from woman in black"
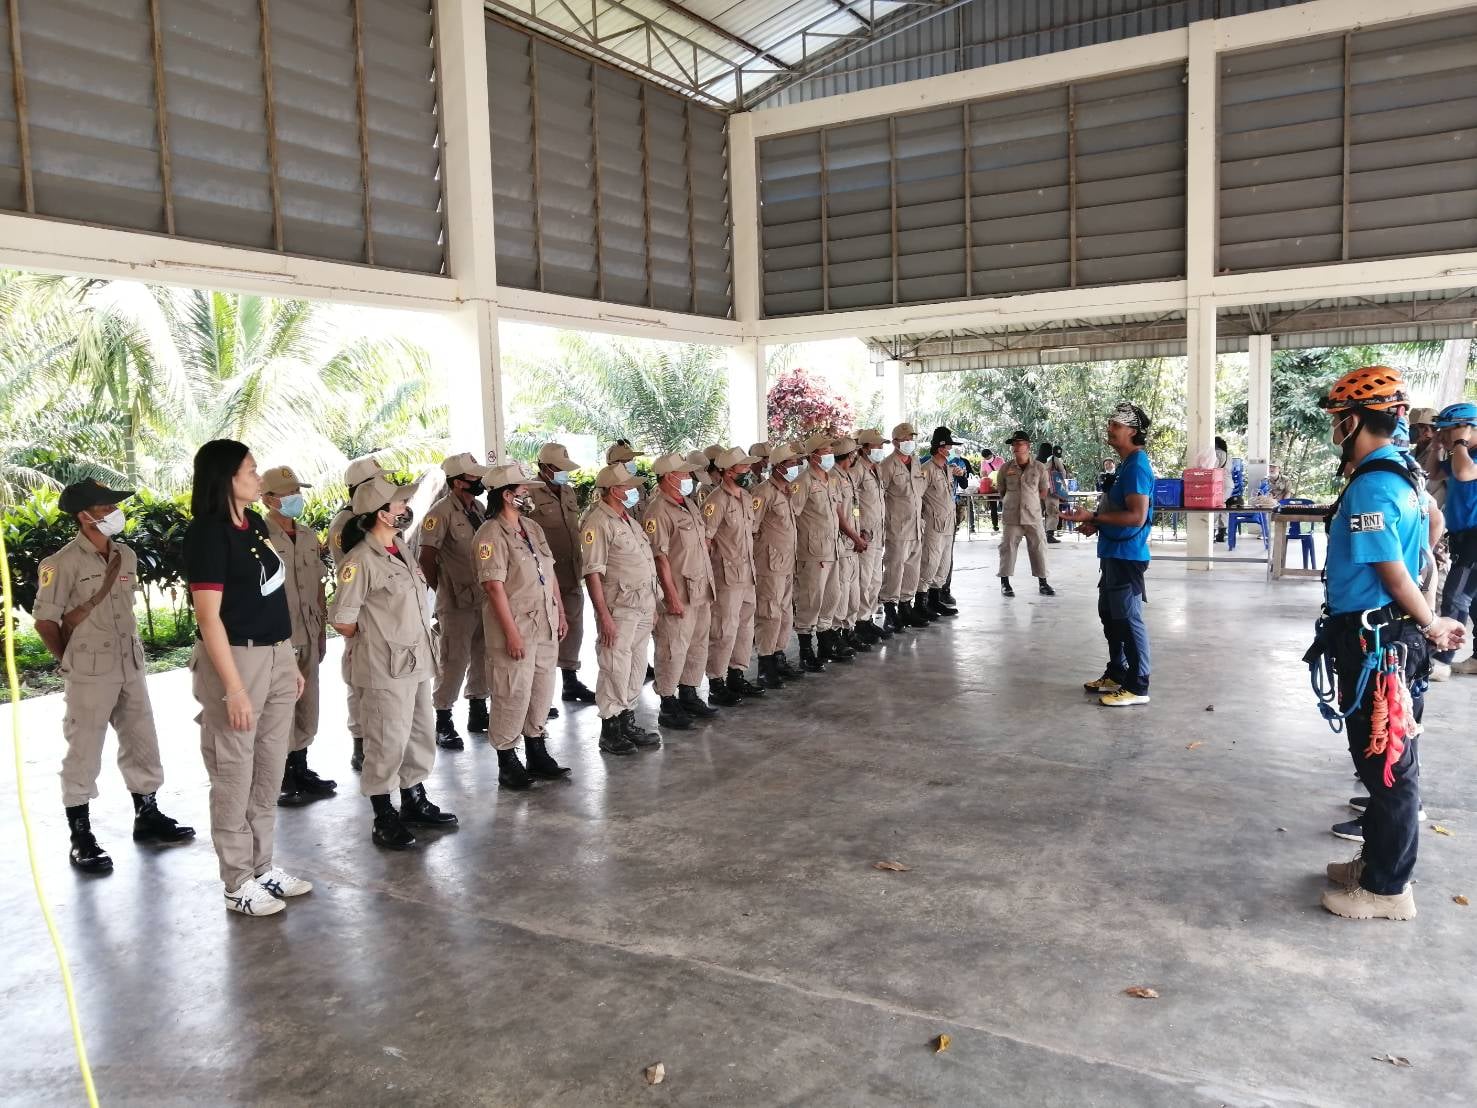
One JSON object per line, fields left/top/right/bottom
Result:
{"left": 703, "top": 446, "right": 764, "bottom": 708}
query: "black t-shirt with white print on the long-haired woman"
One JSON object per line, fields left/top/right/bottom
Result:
{"left": 185, "top": 510, "right": 292, "bottom": 643}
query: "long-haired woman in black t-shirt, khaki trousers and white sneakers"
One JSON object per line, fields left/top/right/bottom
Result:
{"left": 185, "top": 439, "right": 313, "bottom": 916}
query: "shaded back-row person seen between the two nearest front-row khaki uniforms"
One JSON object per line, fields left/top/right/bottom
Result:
{"left": 419, "top": 454, "right": 487, "bottom": 750}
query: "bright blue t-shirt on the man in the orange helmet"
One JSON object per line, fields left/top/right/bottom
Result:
{"left": 1326, "top": 446, "right": 1427, "bottom": 615}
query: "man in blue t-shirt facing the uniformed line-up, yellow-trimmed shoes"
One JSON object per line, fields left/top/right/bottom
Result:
{"left": 1062, "top": 403, "right": 1154, "bottom": 708}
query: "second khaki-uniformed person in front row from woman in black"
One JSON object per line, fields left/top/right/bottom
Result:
{"left": 476, "top": 462, "right": 569, "bottom": 789}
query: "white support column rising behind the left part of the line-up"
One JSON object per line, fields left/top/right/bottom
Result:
{"left": 436, "top": 0, "right": 504, "bottom": 456}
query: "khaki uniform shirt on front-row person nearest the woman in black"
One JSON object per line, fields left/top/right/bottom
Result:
{"left": 328, "top": 535, "right": 431, "bottom": 690}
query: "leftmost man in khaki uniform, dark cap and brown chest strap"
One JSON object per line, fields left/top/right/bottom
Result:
{"left": 31, "top": 480, "right": 195, "bottom": 873}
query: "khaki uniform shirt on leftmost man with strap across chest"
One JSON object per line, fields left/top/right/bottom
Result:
{"left": 31, "top": 535, "right": 143, "bottom": 681}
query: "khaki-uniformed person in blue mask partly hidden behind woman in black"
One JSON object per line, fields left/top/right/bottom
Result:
{"left": 261, "top": 465, "right": 338, "bottom": 807}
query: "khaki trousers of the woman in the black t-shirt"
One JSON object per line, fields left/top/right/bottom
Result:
{"left": 189, "top": 643, "right": 297, "bottom": 892}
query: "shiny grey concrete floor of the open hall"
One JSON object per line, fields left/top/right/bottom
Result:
{"left": 0, "top": 541, "right": 1477, "bottom": 1107}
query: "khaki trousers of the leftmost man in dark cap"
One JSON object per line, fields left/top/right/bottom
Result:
{"left": 62, "top": 660, "right": 164, "bottom": 808}
